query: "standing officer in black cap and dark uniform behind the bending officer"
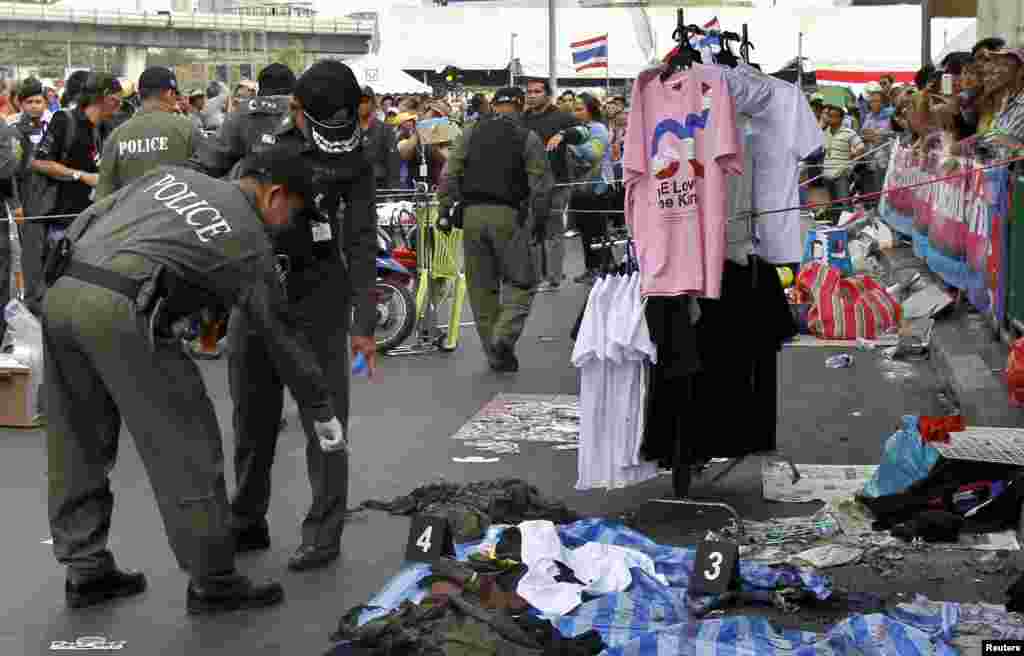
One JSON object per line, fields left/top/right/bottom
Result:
{"left": 218, "top": 60, "right": 377, "bottom": 570}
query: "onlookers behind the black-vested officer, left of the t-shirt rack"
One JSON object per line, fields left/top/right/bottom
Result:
{"left": 352, "top": 80, "right": 629, "bottom": 292}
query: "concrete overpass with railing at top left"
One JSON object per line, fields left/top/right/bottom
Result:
{"left": 0, "top": 2, "right": 374, "bottom": 79}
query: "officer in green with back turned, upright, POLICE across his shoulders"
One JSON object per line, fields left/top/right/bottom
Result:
{"left": 96, "top": 67, "right": 204, "bottom": 201}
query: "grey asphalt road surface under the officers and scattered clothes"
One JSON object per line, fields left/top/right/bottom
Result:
{"left": 0, "top": 243, "right": 1002, "bottom": 656}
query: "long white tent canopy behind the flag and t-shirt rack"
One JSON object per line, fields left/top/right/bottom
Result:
{"left": 380, "top": 4, "right": 971, "bottom": 84}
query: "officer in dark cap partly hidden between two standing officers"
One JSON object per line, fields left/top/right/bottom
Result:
{"left": 191, "top": 63, "right": 295, "bottom": 178}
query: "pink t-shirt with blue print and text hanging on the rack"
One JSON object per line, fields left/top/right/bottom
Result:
{"left": 623, "top": 64, "right": 743, "bottom": 299}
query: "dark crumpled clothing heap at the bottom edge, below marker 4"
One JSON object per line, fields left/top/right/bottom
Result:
{"left": 328, "top": 595, "right": 605, "bottom": 656}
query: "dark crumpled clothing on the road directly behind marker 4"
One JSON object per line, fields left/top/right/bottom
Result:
{"left": 359, "top": 479, "right": 579, "bottom": 542}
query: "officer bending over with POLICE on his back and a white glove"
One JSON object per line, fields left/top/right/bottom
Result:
{"left": 43, "top": 147, "right": 347, "bottom": 613}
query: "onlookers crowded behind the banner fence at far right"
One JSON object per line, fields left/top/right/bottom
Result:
{"left": 805, "top": 38, "right": 1024, "bottom": 216}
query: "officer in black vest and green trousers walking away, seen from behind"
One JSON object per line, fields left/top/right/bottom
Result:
{"left": 439, "top": 87, "right": 554, "bottom": 371}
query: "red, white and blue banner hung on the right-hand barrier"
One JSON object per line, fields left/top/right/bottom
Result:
{"left": 879, "top": 143, "right": 1010, "bottom": 322}
